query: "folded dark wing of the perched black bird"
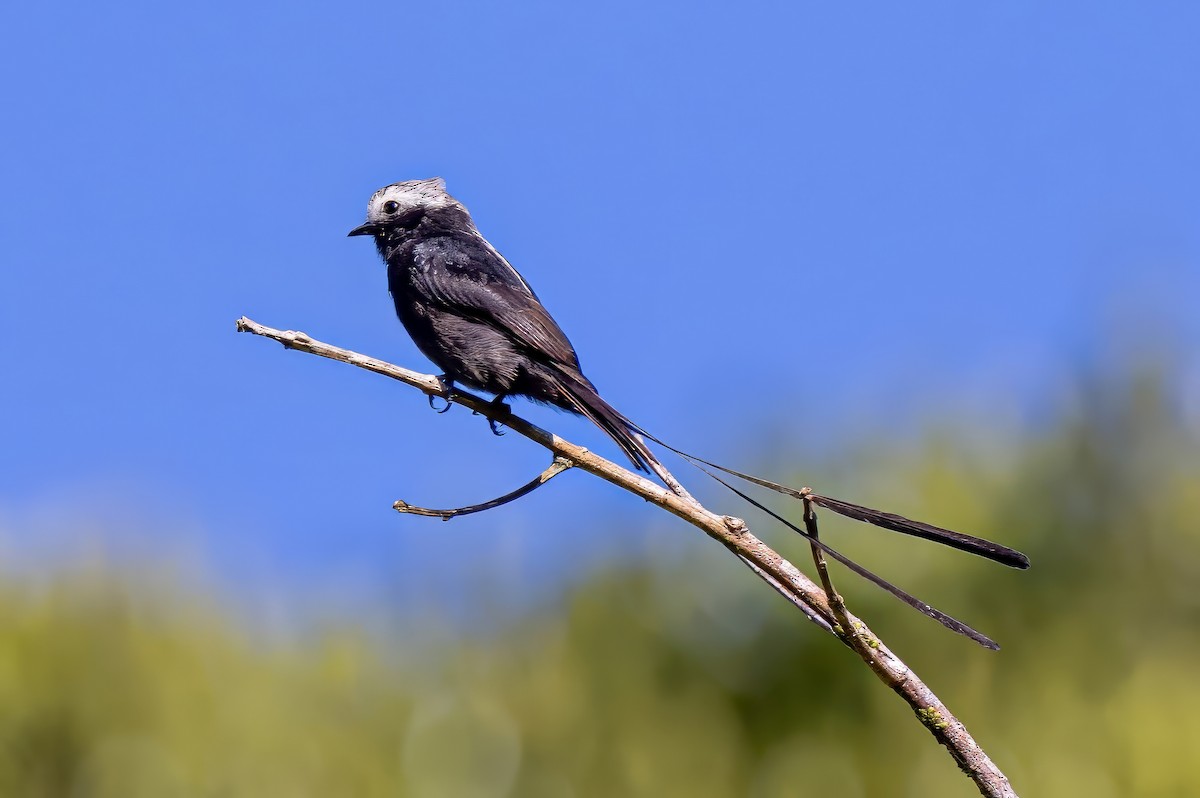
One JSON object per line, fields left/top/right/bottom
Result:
{"left": 412, "top": 238, "right": 580, "bottom": 368}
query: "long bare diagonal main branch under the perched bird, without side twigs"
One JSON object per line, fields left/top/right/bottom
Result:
{"left": 238, "top": 317, "right": 1016, "bottom": 798}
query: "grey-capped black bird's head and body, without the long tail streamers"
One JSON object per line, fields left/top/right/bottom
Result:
{"left": 350, "top": 179, "right": 655, "bottom": 470}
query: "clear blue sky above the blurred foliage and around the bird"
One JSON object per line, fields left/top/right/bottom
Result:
{"left": 0, "top": 1, "right": 1200, "bottom": 612}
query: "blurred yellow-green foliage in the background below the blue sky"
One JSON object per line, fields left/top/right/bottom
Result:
{"left": 0, "top": 364, "right": 1200, "bottom": 798}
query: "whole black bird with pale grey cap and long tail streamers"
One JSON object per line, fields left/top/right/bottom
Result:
{"left": 349, "top": 178, "right": 1030, "bottom": 649}
